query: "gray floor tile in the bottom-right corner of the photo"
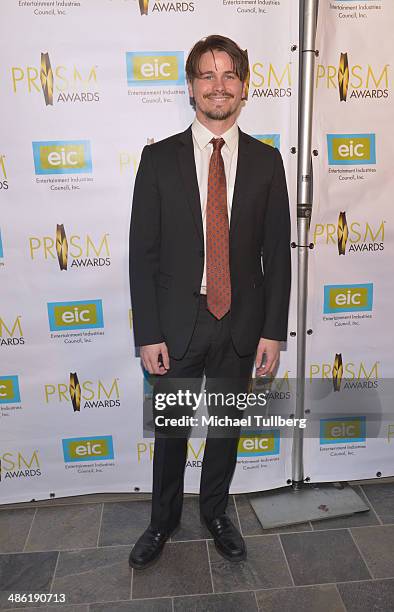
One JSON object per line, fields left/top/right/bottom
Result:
{"left": 337, "top": 580, "right": 394, "bottom": 612}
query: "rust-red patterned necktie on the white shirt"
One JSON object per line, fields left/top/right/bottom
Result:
{"left": 206, "top": 138, "right": 231, "bottom": 319}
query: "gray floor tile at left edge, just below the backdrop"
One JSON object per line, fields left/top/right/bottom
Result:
{"left": 0, "top": 508, "right": 35, "bottom": 553}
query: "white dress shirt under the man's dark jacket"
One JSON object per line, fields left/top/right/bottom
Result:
{"left": 192, "top": 118, "right": 238, "bottom": 293}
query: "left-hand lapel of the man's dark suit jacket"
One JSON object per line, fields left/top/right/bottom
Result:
{"left": 177, "top": 127, "right": 204, "bottom": 243}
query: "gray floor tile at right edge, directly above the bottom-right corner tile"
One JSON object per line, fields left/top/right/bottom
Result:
{"left": 351, "top": 525, "right": 394, "bottom": 580}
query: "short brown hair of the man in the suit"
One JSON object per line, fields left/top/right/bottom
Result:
{"left": 186, "top": 34, "right": 249, "bottom": 83}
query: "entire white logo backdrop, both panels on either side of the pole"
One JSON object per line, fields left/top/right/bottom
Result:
{"left": 0, "top": 0, "right": 394, "bottom": 503}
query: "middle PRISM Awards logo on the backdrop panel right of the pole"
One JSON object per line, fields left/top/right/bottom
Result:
{"left": 313, "top": 211, "right": 386, "bottom": 255}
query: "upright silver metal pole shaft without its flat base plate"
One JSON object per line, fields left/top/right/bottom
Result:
{"left": 292, "top": 0, "right": 319, "bottom": 488}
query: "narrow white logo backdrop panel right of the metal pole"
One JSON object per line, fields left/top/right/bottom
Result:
{"left": 305, "top": 0, "right": 394, "bottom": 481}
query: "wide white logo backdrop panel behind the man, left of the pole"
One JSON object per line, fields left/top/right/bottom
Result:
{"left": 0, "top": 0, "right": 298, "bottom": 503}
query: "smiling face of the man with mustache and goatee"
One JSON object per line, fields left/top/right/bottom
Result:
{"left": 189, "top": 51, "right": 245, "bottom": 121}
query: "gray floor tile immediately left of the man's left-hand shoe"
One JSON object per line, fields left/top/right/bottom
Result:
{"left": 99, "top": 501, "right": 151, "bottom": 546}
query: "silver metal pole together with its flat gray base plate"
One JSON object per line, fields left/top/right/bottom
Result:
{"left": 249, "top": 0, "right": 369, "bottom": 529}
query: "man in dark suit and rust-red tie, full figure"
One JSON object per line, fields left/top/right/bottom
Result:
{"left": 129, "top": 35, "right": 290, "bottom": 568}
